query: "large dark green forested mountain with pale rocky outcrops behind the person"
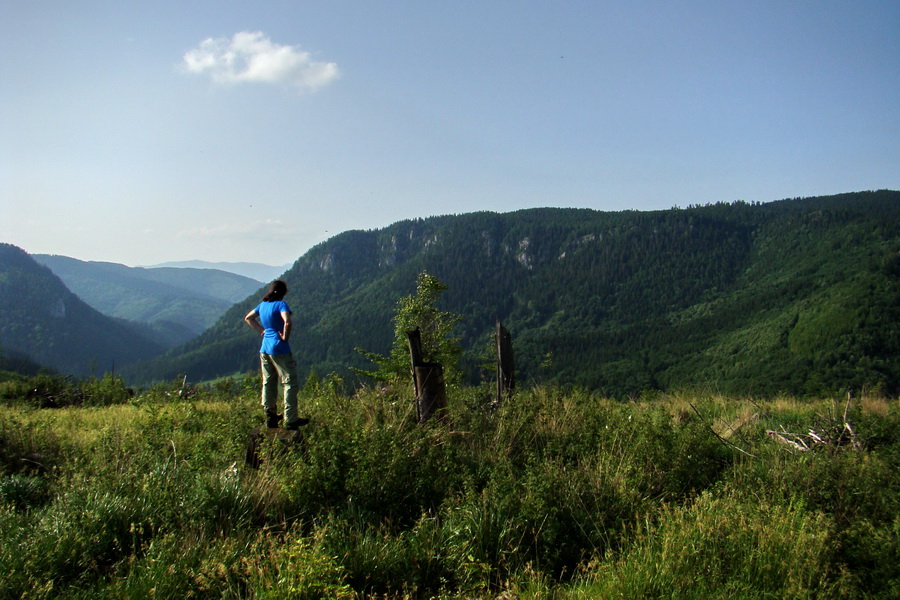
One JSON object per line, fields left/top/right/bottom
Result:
{"left": 134, "top": 191, "right": 900, "bottom": 396}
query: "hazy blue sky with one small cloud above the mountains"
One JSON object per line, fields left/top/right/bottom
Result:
{"left": 0, "top": 0, "right": 900, "bottom": 265}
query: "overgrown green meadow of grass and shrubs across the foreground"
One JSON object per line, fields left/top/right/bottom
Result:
{"left": 0, "top": 377, "right": 900, "bottom": 599}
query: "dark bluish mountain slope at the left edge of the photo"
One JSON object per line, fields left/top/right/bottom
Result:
{"left": 0, "top": 244, "right": 163, "bottom": 376}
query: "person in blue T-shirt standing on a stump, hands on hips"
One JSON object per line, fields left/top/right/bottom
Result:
{"left": 244, "top": 279, "right": 309, "bottom": 430}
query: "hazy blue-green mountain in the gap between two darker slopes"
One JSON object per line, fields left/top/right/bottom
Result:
{"left": 33, "top": 254, "right": 261, "bottom": 347}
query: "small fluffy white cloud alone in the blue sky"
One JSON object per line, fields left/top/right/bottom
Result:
{"left": 182, "top": 31, "right": 340, "bottom": 91}
